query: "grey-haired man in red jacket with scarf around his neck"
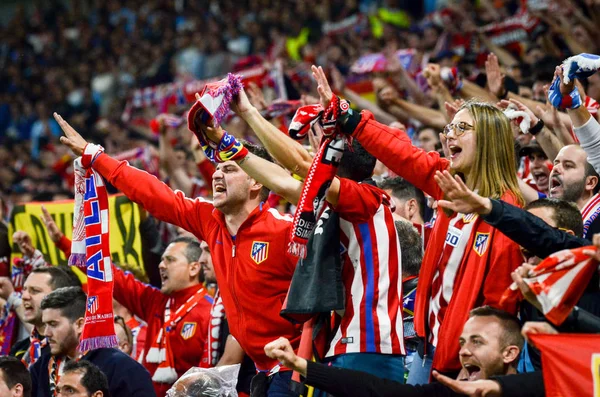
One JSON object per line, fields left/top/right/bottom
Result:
{"left": 113, "top": 237, "right": 213, "bottom": 396}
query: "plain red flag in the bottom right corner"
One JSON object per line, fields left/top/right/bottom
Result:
{"left": 529, "top": 334, "right": 600, "bottom": 397}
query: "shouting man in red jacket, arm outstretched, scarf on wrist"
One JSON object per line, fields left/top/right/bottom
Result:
{"left": 54, "top": 114, "right": 300, "bottom": 397}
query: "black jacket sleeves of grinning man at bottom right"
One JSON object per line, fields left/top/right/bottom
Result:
{"left": 306, "top": 362, "right": 545, "bottom": 397}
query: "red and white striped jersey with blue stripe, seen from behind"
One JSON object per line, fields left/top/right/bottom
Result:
{"left": 327, "top": 179, "right": 406, "bottom": 357}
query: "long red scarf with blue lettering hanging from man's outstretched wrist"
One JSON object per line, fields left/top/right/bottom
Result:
{"left": 69, "top": 151, "right": 118, "bottom": 351}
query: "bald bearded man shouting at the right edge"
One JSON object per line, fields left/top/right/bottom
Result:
{"left": 550, "top": 145, "right": 600, "bottom": 240}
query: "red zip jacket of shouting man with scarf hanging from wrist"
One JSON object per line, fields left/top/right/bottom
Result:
{"left": 93, "top": 154, "right": 300, "bottom": 371}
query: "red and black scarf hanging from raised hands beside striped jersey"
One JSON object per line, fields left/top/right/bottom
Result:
{"left": 289, "top": 96, "right": 350, "bottom": 258}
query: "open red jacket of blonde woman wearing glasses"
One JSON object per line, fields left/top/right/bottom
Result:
{"left": 353, "top": 111, "right": 523, "bottom": 371}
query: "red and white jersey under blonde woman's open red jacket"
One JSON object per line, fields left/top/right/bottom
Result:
{"left": 429, "top": 213, "right": 477, "bottom": 346}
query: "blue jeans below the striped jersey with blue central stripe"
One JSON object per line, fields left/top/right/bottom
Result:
{"left": 313, "top": 353, "right": 404, "bottom": 397}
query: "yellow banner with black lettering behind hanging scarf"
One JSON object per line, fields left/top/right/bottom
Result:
{"left": 9, "top": 195, "right": 145, "bottom": 275}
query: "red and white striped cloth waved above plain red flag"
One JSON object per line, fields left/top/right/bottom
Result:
{"left": 500, "top": 246, "right": 598, "bottom": 325}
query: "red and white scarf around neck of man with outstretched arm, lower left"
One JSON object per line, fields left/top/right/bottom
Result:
{"left": 146, "top": 287, "right": 206, "bottom": 383}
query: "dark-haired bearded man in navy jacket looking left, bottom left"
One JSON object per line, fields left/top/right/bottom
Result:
{"left": 29, "top": 287, "right": 155, "bottom": 397}
